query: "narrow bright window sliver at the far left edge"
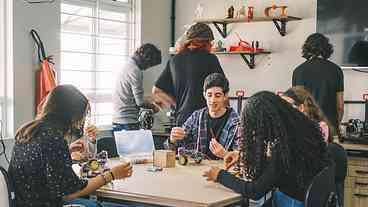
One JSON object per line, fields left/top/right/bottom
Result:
{"left": 0, "top": 0, "right": 14, "bottom": 137}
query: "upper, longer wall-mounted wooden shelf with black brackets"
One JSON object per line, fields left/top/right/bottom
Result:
{"left": 194, "top": 16, "right": 302, "bottom": 38}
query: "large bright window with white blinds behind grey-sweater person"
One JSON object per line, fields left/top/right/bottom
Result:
{"left": 59, "top": 0, "right": 137, "bottom": 125}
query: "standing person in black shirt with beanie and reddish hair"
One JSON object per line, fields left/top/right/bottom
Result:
{"left": 152, "top": 23, "right": 224, "bottom": 126}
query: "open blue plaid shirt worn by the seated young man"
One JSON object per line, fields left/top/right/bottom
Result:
{"left": 170, "top": 107, "right": 240, "bottom": 154}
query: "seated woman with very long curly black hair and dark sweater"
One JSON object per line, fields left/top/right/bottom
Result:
{"left": 204, "top": 92, "right": 329, "bottom": 207}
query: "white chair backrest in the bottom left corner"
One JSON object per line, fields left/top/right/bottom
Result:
{"left": 0, "top": 166, "right": 15, "bottom": 207}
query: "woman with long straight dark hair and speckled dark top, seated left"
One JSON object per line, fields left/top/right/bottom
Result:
{"left": 9, "top": 85, "right": 132, "bottom": 207}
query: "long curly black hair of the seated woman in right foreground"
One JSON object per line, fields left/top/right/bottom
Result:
{"left": 240, "top": 91, "right": 328, "bottom": 189}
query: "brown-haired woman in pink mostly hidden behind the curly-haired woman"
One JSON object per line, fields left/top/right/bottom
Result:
{"left": 281, "top": 87, "right": 347, "bottom": 204}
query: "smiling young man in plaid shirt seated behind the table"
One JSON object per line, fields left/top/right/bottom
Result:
{"left": 168, "top": 73, "right": 239, "bottom": 159}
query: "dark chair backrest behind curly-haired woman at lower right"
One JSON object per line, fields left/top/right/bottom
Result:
{"left": 304, "top": 165, "right": 337, "bottom": 207}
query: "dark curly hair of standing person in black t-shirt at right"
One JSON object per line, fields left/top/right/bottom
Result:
{"left": 302, "top": 33, "right": 333, "bottom": 60}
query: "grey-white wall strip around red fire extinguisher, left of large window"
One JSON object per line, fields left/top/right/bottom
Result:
{"left": 13, "top": 0, "right": 60, "bottom": 129}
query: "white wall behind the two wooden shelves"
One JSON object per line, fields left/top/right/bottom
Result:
{"left": 176, "top": 0, "right": 368, "bottom": 119}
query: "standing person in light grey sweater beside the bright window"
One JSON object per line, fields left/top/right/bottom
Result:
{"left": 112, "top": 43, "right": 161, "bottom": 131}
